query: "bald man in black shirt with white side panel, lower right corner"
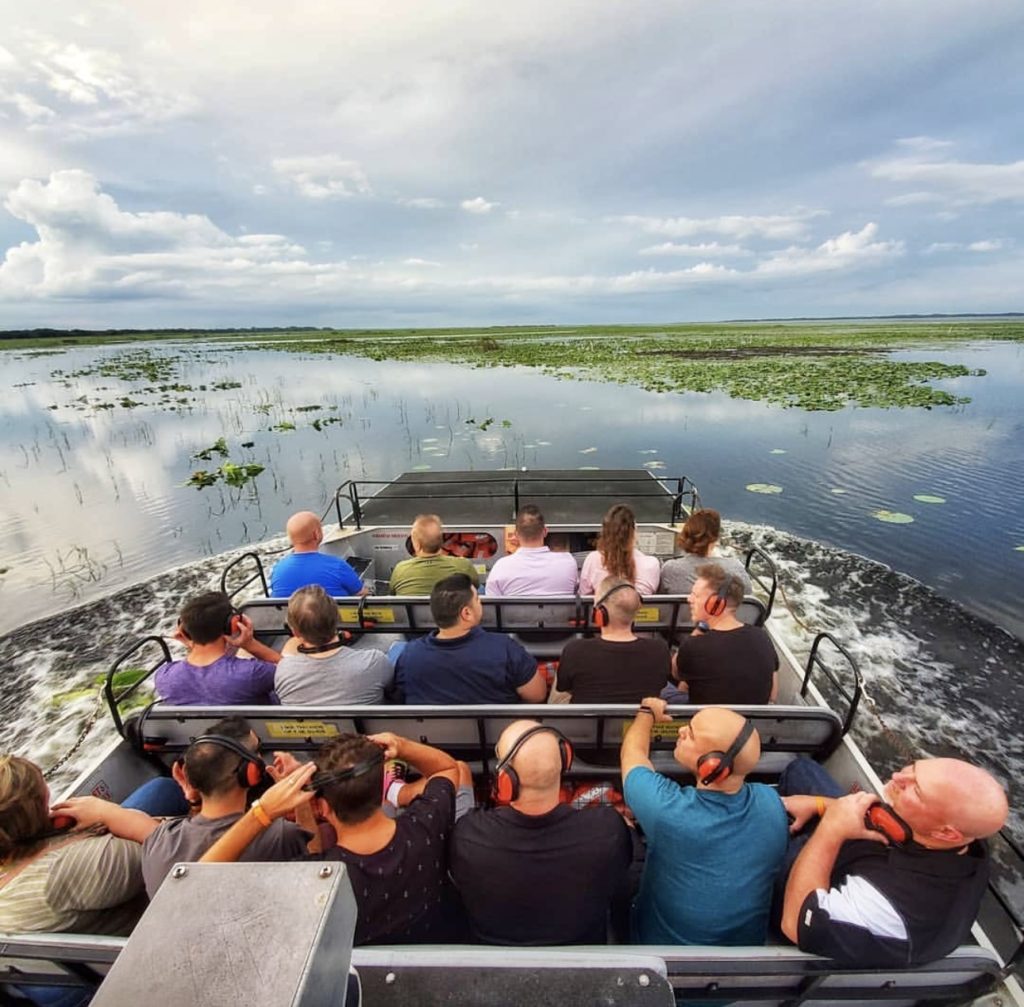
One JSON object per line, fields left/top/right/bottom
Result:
{"left": 779, "top": 759, "right": 1008, "bottom": 968}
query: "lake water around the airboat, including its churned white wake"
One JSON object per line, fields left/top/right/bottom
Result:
{"left": 0, "top": 342, "right": 1024, "bottom": 848}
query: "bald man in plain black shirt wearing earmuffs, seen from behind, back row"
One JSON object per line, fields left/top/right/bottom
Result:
{"left": 450, "top": 720, "right": 633, "bottom": 946}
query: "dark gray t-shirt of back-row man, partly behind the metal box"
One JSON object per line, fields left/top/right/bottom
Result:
{"left": 142, "top": 811, "right": 309, "bottom": 898}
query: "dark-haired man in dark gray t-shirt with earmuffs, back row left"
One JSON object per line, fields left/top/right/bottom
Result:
{"left": 142, "top": 717, "right": 309, "bottom": 898}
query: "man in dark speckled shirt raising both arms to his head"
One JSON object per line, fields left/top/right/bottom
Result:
{"left": 203, "top": 733, "right": 473, "bottom": 945}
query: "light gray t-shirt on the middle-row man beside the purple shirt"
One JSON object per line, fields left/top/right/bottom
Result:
{"left": 273, "top": 646, "right": 394, "bottom": 706}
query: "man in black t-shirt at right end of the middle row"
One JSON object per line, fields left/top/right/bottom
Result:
{"left": 674, "top": 563, "right": 778, "bottom": 706}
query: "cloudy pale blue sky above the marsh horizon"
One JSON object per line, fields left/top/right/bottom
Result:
{"left": 0, "top": 0, "right": 1024, "bottom": 329}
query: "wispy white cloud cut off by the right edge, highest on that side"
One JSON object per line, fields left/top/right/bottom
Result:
{"left": 867, "top": 137, "right": 1024, "bottom": 206}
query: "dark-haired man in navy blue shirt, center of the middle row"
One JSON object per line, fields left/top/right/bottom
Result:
{"left": 394, "top": 574, "right": 548, "bottom": 705}
